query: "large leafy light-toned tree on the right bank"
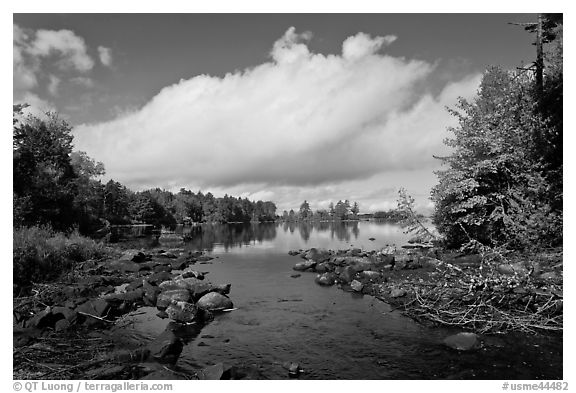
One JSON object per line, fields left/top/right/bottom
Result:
{"left": 432, "top": 68, "right": 561, "bottom": 248}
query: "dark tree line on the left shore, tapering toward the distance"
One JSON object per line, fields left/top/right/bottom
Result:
{"left": 13, "top": 105, "right": 276, "bottom": 234}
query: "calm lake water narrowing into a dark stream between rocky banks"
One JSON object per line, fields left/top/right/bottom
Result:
{"left": 109, "top": 222, "right": 562, "bottom": 379}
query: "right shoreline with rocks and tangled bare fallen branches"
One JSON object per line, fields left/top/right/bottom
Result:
{"left": 289, "top": 244, "right": 563, "bottom": 334}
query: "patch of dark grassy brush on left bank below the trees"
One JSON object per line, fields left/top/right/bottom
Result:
{"left": 13, "top": 226, "right": 110, "bottom": 290}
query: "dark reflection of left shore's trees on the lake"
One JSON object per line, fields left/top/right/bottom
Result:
{"left": 183, "top": 223, "right": 276, "bottom": 250}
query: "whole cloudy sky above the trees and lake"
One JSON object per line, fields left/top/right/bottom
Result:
{"left": 13, "top": 14, "right": 535, "bottom": 212}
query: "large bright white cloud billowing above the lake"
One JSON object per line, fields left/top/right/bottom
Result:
{"left": 75, "top": 28, "right": 478, "bottom": 194}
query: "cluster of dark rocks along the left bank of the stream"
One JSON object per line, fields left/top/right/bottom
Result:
{"left": 14, "top": 250, "right": 233, "bottom": 372}
